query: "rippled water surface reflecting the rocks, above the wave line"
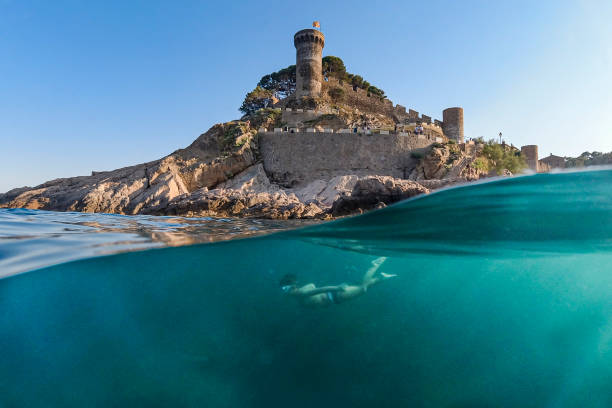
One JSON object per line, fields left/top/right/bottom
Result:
{"left": 0, "top": 208, "right": 312, "bottom": 278}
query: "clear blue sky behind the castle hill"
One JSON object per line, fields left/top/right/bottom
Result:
{"left": 0, "top": 0, "right": 612, "bottom": 191}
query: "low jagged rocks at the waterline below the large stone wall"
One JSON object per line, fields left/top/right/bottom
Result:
{"left": 143, "top": 164, "right": 429, "bottom": 219}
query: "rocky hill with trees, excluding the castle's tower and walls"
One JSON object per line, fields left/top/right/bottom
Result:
{"left": 0, "top": 57, "right": 520, "bottom": 219}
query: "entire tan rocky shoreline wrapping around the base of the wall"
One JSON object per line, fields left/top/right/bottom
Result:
{"left": 0, "top": 121, "right": 483, "bottom": 219}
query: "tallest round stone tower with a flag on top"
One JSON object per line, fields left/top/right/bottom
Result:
{"left": 293, "top": 29, "right": 325, "bottom": 98}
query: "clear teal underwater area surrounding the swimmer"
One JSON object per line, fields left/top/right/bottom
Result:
{"left": 0, "top": 170, "right": 612, "bottom": 407}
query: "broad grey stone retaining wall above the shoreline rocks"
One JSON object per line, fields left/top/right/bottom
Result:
{"left": 258, "top": 132, "right": 435, "bottom": 186}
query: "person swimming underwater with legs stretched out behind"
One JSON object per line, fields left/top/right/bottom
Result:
{"left": 280, "top": 257, "right": 397, "bottom": 307}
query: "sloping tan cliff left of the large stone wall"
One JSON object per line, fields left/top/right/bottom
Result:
{"left": 0, "top": 123, "right": 256, "bottom": 214}
